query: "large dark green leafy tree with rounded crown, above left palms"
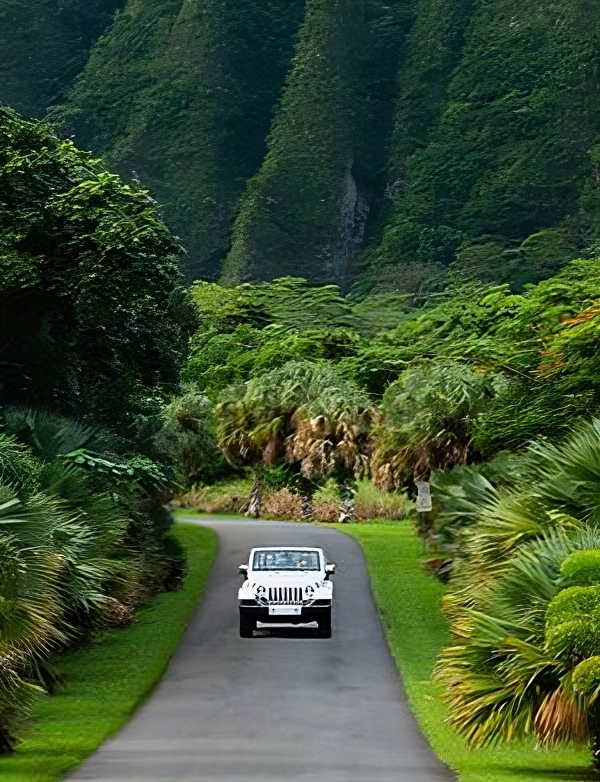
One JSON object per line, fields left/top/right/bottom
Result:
{"left": 0, "top": 109, "right": 187, "bottom": 435}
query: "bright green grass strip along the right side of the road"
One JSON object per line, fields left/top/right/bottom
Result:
{"left": 340, "top": 523, "right": 597, "bottom": 782}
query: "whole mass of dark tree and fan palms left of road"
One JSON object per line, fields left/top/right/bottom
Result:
{"left": 0, "top": 109, "right": 196, "bottom": 752}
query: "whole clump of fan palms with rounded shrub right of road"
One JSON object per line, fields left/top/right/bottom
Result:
{"left": 438, "top": 421, "right": 600, "bottom": 763}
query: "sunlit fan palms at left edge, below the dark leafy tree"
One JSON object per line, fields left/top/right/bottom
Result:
{"left": 0, "top": 411, "right": 137, "bottom": 751}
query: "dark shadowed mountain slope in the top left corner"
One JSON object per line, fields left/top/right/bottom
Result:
{"left": 0, "top": 0, "right": 124, "bottom": 117}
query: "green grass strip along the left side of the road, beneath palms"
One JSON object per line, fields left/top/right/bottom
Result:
{"left": 0, "top": 524, "right": 217, "bottom": 782}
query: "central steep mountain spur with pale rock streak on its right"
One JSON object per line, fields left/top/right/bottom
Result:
{"left": 222, "top": 0, "right": 410, "bottom": 286}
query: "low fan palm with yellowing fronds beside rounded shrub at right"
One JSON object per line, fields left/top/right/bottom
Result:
{"left": 438, "top": 530, "right": 600, "bottom": 746}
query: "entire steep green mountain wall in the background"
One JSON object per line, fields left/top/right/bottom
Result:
{"left": 0, "top": 0, "right": 600, "bottom": 296}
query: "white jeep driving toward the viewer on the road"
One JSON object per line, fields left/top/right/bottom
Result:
{"left": 238, "top": 546, "right": 335, "bottom": 638}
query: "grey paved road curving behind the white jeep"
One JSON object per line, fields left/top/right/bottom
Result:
{"left": 70, "top": 517, "right": 454, "bottom": 782}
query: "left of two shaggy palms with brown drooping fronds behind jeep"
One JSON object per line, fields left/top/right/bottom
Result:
{"left": 216, "top": 361, "right": 373, "bottom": 516}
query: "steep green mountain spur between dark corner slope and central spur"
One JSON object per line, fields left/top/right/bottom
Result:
{"left": 52, "top": 0, "right": 304, "bottom": 278}
